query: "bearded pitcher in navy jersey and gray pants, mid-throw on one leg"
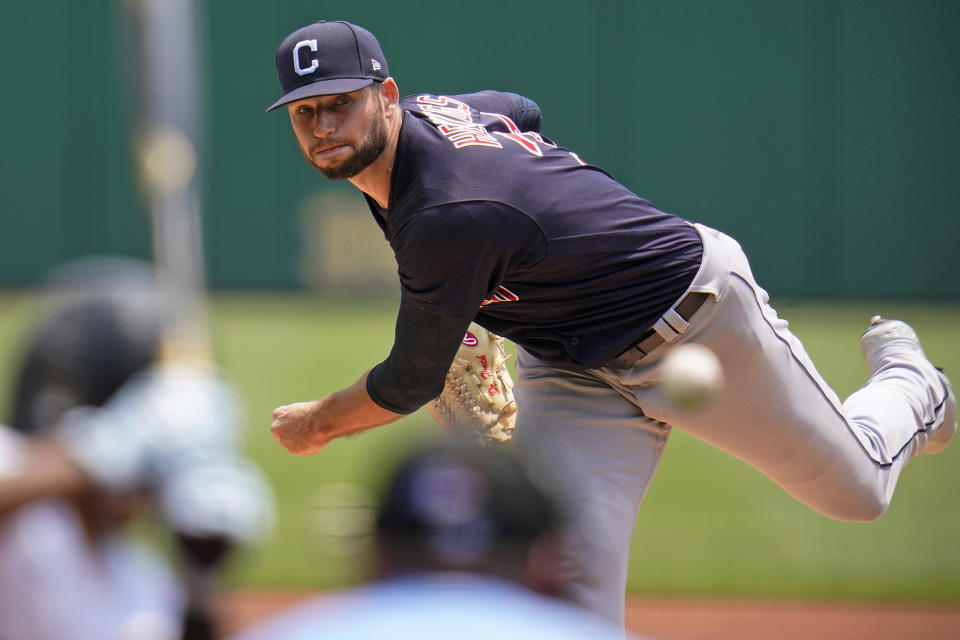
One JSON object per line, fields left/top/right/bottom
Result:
{"left": 262, "top": 22, "right": 956, "bottom": 623}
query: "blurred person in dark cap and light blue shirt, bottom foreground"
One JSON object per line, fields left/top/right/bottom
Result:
{"left": 226, "top": 438, "right": 644, "bottom": 640}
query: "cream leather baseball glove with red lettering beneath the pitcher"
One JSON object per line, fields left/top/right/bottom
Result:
{"left": 427, "top": 323, "right": 517, "bottom": 445}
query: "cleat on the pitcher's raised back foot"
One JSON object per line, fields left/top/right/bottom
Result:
{"left": 860, "top": 316, "right": 957, "bottom": 453}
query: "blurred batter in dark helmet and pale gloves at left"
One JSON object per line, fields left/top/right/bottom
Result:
{"left": 0, "top": 259, "right": 273, "bottom": 640}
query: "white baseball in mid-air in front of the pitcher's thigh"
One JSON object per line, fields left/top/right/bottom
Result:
{"left": 660, "top": 344, "right": 723, "bottom": 409}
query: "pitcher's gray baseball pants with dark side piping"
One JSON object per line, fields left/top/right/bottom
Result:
{"left": 514, "top": 225, "right": 942, "bottom": 624}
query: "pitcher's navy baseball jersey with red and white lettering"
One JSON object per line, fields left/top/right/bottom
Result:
{"left": 367, "top": 91, "right": 702, "bottom": 413}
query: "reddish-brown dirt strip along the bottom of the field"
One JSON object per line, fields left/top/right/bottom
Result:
{"left": 219, "top": 591, "right": 960, "bottom": 640}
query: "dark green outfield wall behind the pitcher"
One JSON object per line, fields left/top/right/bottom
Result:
{"left": 0, "top": 0, "right": 960, "bottom": 300}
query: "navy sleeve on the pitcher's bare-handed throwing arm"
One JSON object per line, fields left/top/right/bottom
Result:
{"left": 367, "top": 202, "right": 545, "bottom": 413}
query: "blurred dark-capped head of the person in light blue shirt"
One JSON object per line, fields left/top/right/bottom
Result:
{"left": 376, "top": 440, "right": 564, "bottom": 595}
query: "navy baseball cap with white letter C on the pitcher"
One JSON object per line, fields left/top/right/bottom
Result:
{"left": 267, "top": 21, "right": 390, "bottom": 111}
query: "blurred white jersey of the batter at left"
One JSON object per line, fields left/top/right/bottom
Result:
{"left": 0, "top": 426, "right": 185, "bottom": 640}
